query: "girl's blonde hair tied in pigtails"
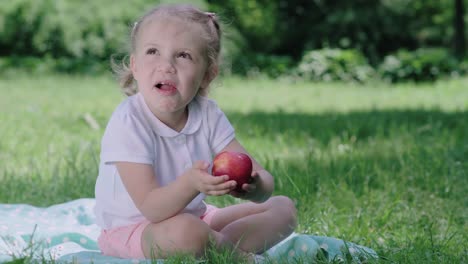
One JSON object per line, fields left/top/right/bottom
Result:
{"left": 111, "top": 4, "right": 221, "bottom": 96}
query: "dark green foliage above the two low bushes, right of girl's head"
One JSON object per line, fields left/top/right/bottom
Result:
{"left": 208, "top": 0, "right": 462, "bottom": 65}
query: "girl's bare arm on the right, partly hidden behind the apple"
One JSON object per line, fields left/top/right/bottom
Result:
{"left": 221, "top": 139, "right": 274, "bottom": 203}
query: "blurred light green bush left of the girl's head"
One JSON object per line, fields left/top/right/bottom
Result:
{"left": 0, "top": 0, "right": 205, "bottom": 72}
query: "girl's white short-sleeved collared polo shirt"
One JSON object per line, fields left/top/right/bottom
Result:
{"left": 94, "top": 93, "right": 235, "bottom": 229}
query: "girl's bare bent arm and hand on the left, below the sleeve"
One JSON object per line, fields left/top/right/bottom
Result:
{"left": 116, "top": 161, "right": 235, "bottom": 223}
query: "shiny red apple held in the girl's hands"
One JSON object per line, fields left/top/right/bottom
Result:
{"left": 211, "top": 151, "right": 252, "bottom": 192}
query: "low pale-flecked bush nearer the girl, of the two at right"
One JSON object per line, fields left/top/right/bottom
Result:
{"left": 295, "top": 49, "right": 374, "bottom": 82}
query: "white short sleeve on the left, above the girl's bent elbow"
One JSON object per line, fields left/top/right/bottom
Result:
{"left": 101, "top": 112, "right": 154, "bottom": 165}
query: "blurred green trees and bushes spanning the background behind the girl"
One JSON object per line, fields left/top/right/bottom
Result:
{"left": 0, "top": 0, "right": 468, "bottom": 82}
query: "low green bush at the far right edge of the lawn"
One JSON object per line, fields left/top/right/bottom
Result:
{"left": 378, "top": 48, "right": 465, "bottom": 82}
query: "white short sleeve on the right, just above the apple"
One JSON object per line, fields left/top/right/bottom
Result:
{"left": 207, "top": 100, "right": 235, "bottom": 153}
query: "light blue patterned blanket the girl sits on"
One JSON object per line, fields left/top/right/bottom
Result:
{"left": 0, "top": 199, "right": 377, "bottom": 264}
